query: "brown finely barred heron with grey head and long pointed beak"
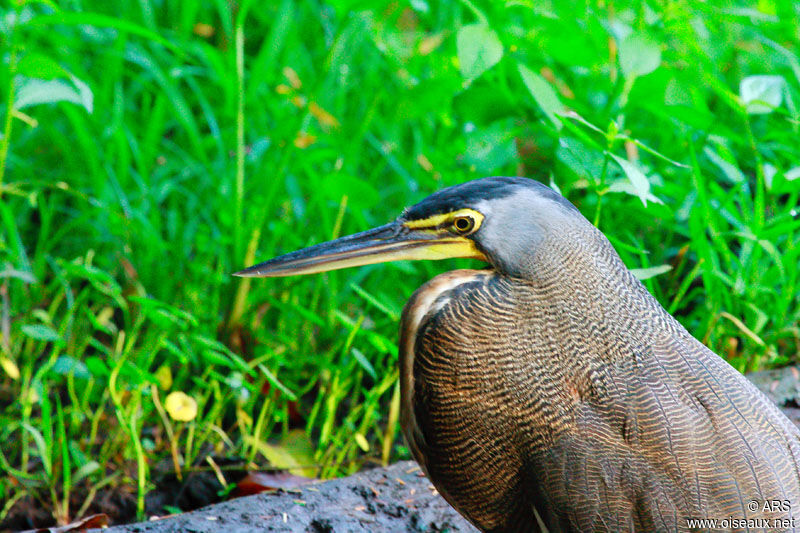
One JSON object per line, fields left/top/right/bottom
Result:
{"left": 237, "top": 177, "right": 800, "bottom": 532}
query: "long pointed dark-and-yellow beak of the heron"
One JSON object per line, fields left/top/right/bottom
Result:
{"left": 234, "top": 221, "right": 486, "bottom": 278}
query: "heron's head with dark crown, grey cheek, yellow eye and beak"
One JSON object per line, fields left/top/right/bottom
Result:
{"left": 235, "top": 177, "right": 588, "bottom": 277}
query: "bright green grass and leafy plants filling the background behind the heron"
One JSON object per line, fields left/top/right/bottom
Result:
{"left": 0, "top": 0, "right": 800, "bottom": 522}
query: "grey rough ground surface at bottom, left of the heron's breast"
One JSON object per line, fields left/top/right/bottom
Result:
{"left": 98, "top": 461, "right": 477, "bottom": 533}
